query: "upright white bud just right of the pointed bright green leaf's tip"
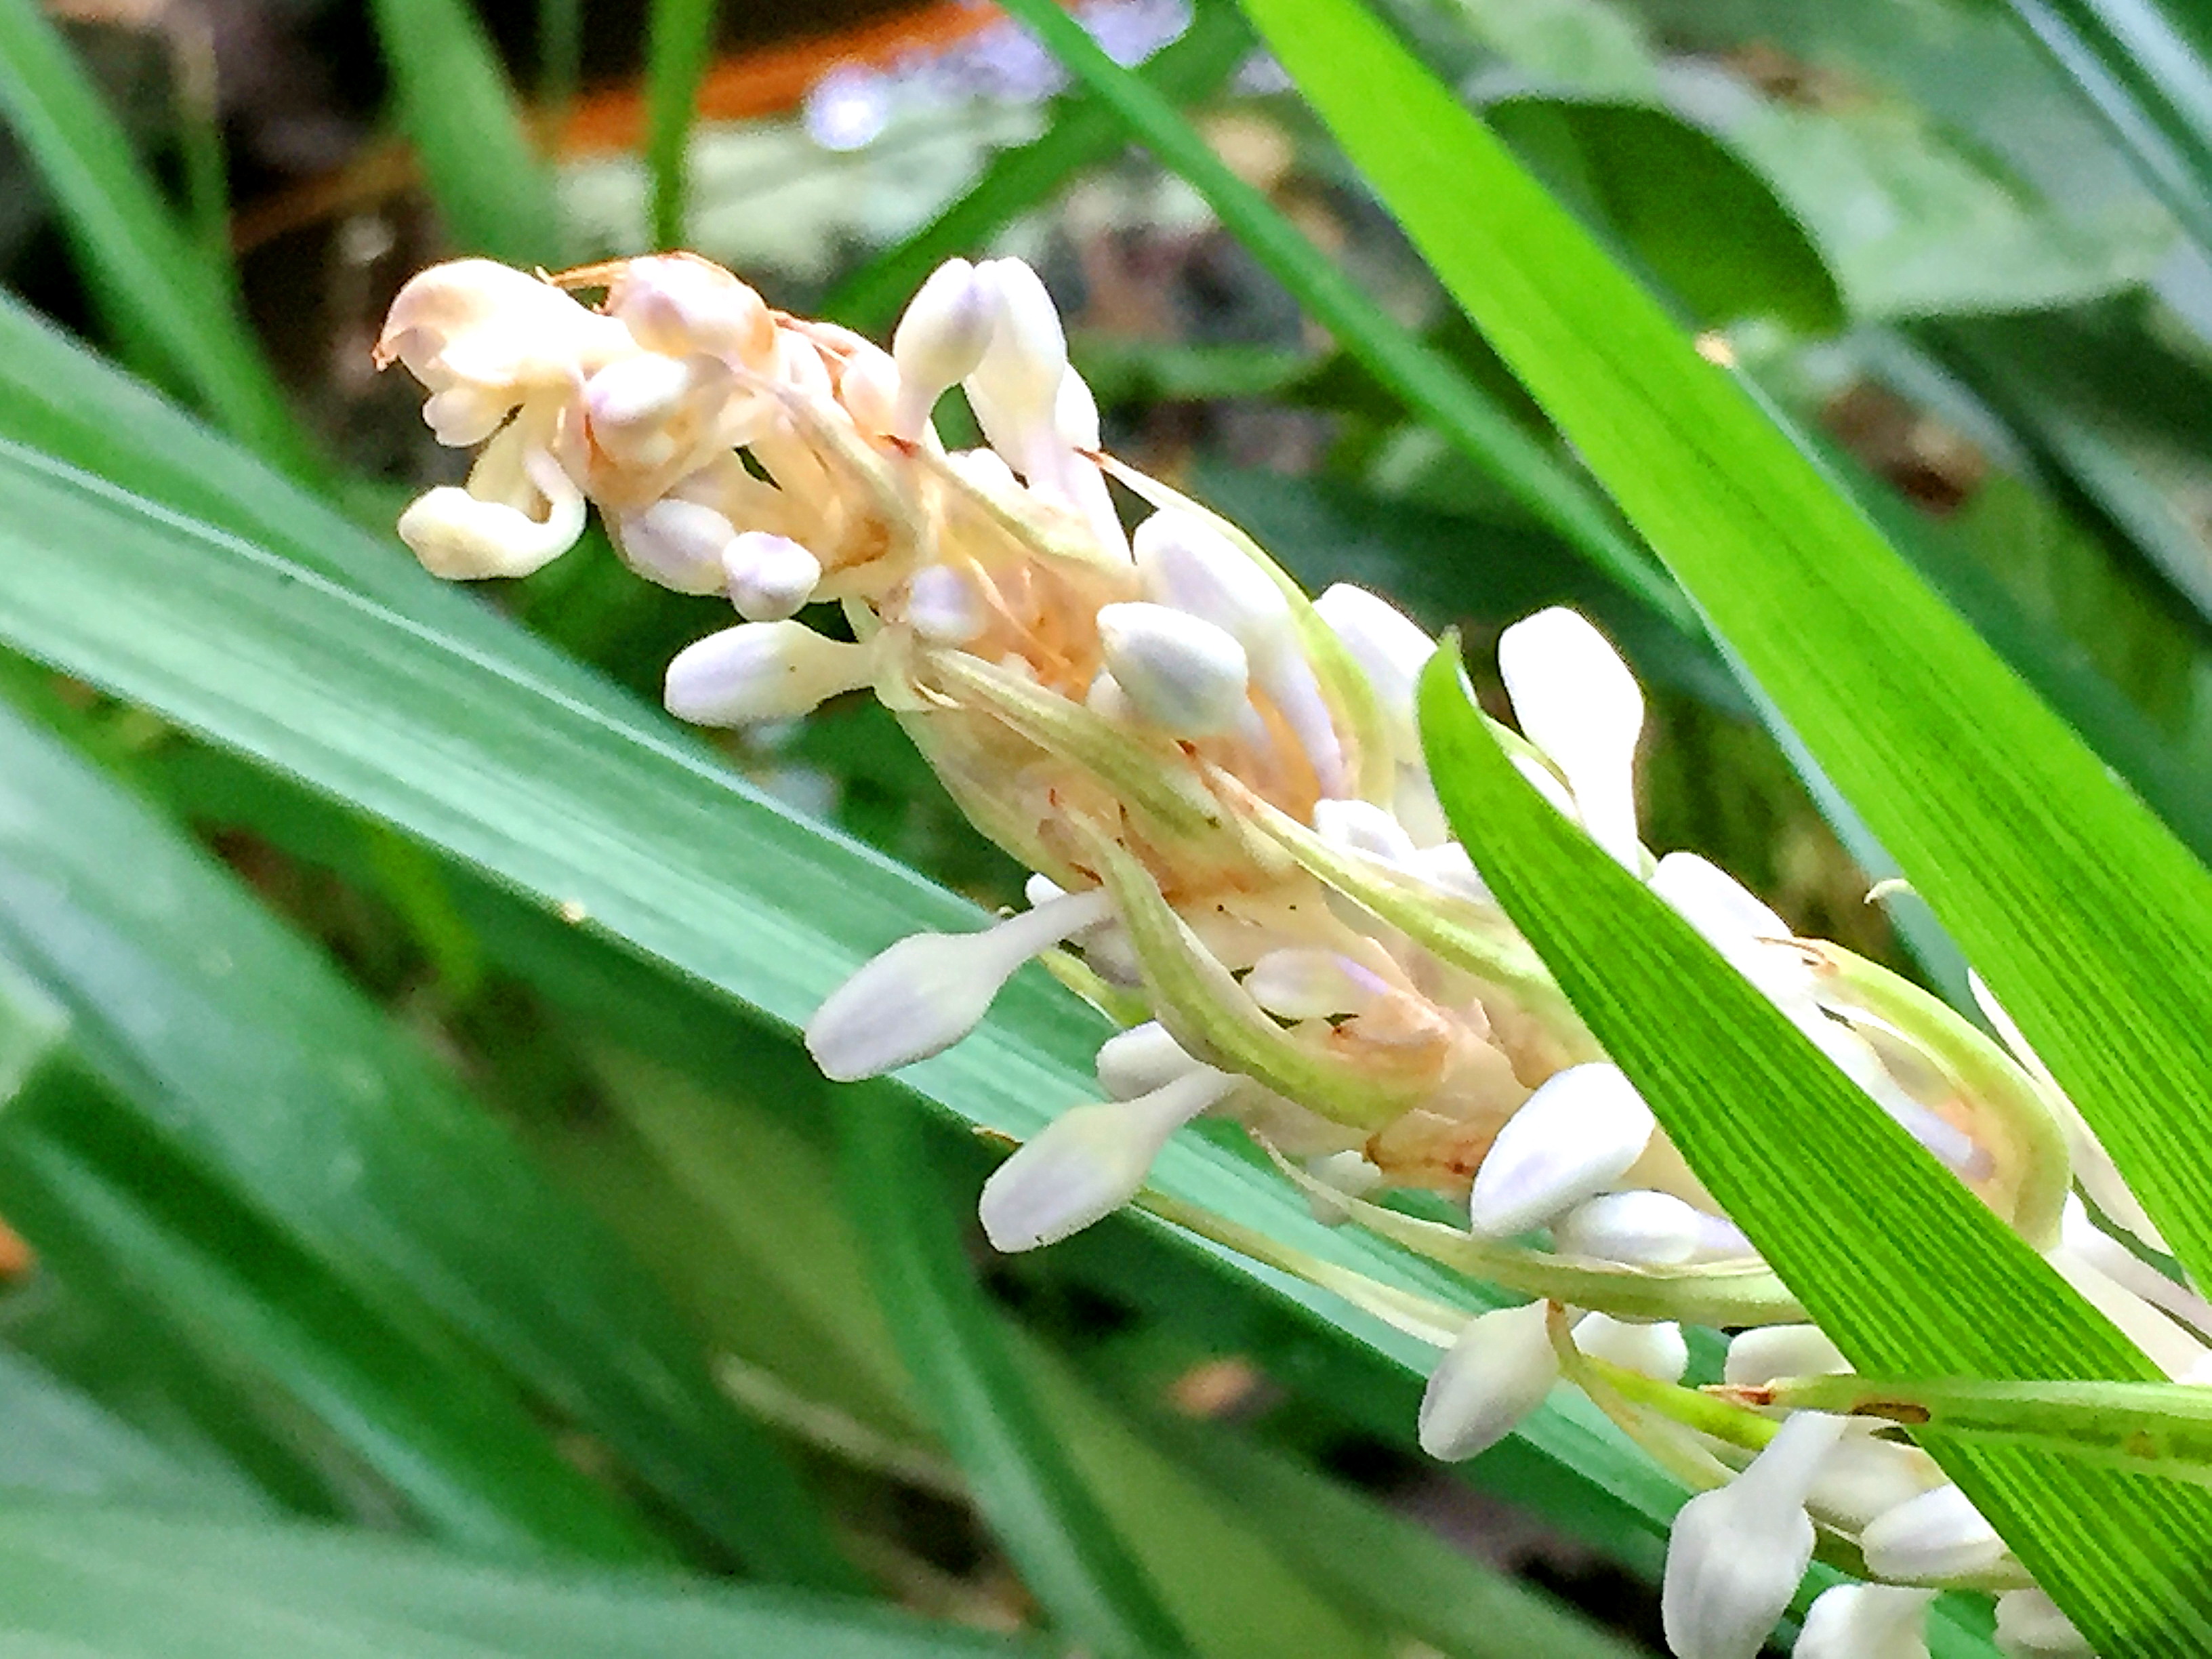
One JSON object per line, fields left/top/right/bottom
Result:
{"left": 1498, "top": 606, "right": 1643, "bottom": 876}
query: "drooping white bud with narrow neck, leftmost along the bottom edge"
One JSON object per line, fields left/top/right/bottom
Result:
{"left": 1659, "top": 1411, "right": 1845, "bottom": 1659}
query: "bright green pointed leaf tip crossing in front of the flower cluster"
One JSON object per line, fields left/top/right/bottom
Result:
{"left": 1420, "top": 653, "right": 2212, "bottom": 1654}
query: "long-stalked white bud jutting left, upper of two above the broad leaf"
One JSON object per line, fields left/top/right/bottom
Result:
{"left": 805, "top": 889, "right": 1113, "bottom": 1084}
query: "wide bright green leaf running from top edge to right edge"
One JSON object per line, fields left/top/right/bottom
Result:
{"left": 1246, "top": 0, "right": 2212, "bottom": 1309}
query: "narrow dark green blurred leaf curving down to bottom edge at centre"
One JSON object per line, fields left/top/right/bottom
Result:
{"left": 838, "top": 1084, "right": 1190, "bottom": 1659}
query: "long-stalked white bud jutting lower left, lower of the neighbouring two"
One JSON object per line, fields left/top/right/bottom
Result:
{"left": 975, "top": 1066, "right": 1237, "bottom": 1254}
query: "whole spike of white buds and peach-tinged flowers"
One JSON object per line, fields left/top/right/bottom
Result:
{"left": 378, "top": 254, "right": 2205, "bottom": 1659}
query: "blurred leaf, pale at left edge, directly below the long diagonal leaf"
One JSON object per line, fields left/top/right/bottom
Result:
{"left": 0, "top": 714, "right": 854, "bottom": 1586}
